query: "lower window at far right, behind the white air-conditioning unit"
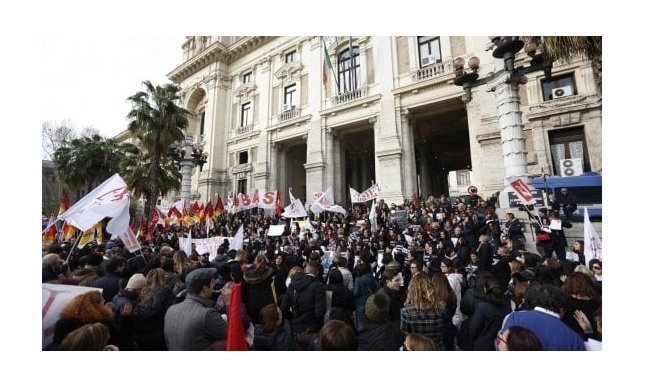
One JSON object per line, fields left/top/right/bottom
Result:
{"left": 549, "top": 127, "right": 590, "bottom": 176}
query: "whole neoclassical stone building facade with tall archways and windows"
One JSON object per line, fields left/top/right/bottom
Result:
{"left": 119, "top": 36, "right": 602, "bottom": 204}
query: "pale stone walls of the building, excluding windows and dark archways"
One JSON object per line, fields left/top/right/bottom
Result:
{"left": 169, "top": 36, "right": 602, "bottom": 203}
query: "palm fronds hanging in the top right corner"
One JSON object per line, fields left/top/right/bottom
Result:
{"left": 522, "top": 36, "right": 602, "bottom": 96}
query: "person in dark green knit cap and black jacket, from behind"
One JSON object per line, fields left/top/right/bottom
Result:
{"left": 358, "top": 292, "right": 403, "bottom": 351}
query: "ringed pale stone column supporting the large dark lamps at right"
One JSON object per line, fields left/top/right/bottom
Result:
{"left": 487, "top": 71, "right": 530, "bottom": 207}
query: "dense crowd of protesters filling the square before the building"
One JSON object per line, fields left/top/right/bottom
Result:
{"left": 43, "top": 191, "right": 602, "bottom": 351}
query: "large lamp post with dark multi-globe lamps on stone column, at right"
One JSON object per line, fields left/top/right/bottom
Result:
{"left": 453, "top": 36, "right": 551, "bottom": 207}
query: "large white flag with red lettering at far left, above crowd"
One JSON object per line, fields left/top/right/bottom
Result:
{"left": 58, "top": 173, "right": 130, "bottom": 235}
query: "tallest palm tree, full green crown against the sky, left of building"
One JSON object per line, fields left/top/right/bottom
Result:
{"left": 127, "top": 81, "right": 188, "bottom": 217}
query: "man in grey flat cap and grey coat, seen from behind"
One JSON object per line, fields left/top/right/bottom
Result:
{"left": 164, "top": 268, "right": 230, "bottom": 351}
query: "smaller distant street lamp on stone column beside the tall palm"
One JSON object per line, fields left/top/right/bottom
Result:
{"left": 170, "top": 134, "right": 208, "bottom": 203}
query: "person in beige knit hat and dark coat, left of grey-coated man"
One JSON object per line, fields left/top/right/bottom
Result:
{"left": 112, "top": 273, "right": 146, "bottom": 351}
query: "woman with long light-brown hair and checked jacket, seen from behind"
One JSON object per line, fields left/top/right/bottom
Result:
{"left": 400, "top": 273, "right": 445, "bottom": 349}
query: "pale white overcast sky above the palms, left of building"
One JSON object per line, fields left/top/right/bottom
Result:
{"left": 40, "top": 35, "right": 185, "bottom": 137}
